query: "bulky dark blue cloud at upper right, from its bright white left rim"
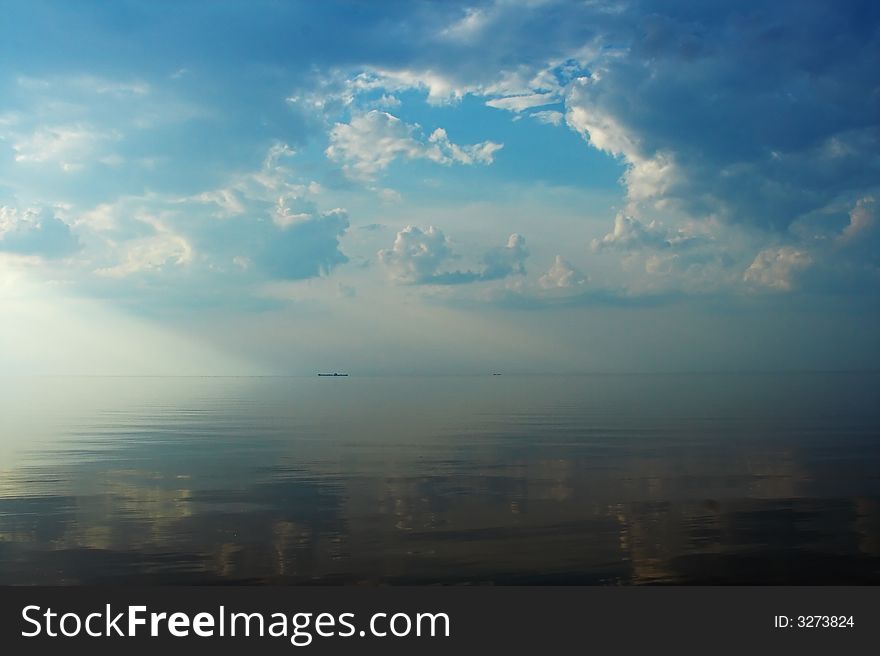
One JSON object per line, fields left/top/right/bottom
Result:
{"left": 566, "top": 2, "right": 880, "bottom": 230}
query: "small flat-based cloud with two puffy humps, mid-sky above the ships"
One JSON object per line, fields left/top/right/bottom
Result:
{"left": 378, "top": 226, "right": 528, "bottom": 285}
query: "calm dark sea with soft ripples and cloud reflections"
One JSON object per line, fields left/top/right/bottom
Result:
{"left": 0, "top": 373, "right": 880, "bottom": 585}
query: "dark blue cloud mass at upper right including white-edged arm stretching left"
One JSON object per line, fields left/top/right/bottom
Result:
{"left": 296, "top": 0, "right": 880, "bottom": 238}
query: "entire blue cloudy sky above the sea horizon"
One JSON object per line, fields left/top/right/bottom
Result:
{"left": 0, "top": 0, "right": 880, "bottom": 375}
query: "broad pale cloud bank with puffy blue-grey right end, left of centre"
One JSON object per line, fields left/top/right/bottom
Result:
{"left": 55, "top": 143, "right": 349, "bottom": 304}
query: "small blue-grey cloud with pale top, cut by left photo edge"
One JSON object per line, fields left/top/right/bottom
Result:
{"left": 0, "top": 206, "right": 81, "bottom": 258}
